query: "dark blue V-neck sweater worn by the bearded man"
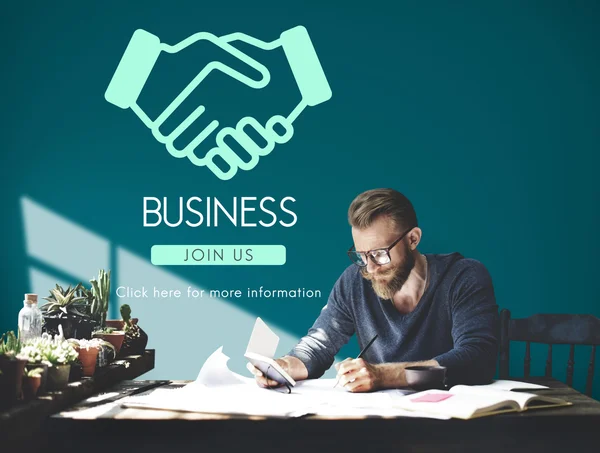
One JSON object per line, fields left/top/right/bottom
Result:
{"left": 289, "top": 253, "right": 499, "bottom": 385}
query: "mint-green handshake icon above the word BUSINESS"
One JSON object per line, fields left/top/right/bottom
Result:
{"left": 104, "top": 26, "right": 331, "bottom": 180}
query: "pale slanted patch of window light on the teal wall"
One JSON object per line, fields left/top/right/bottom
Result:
{"left": 21, "top": 196, "right": 342, "bottom": 379}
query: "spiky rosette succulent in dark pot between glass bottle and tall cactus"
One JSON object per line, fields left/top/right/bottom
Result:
{"left": 41, "top": 283, "right": 95, "bottom": 338}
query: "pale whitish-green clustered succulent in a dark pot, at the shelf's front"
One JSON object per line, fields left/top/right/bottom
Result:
{"left": 40, "top": 326, "right": 78, "bottom": 390}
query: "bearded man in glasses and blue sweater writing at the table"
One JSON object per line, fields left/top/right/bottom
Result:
{"left": 249, "top": 189, "right": 498, "bottom": 392}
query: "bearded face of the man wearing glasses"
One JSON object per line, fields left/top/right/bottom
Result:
{"left": 352, "top": 217, "right": 415, "bottom": 300}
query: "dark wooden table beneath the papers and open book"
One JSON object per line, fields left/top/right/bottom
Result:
{"left": 48, "top": 378, "right": 600, "bottom": 453}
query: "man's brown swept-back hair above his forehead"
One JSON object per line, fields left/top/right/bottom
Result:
{"left": 348, "top": 189, "right": 418, "bottom": 230}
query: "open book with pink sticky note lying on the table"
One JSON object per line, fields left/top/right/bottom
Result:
{"left": 395, "top": 385, "right": 572, "bottom": 420}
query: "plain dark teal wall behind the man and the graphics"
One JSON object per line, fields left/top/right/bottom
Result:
{"left": 0, "top": 0, "right": 600, "bottom": 398}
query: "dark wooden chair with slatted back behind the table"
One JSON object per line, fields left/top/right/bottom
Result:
{"left": 498, "top": 309, "right": 600, "bottom": 397}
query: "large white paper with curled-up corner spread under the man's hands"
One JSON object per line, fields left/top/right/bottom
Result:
{"left": 122, "top": 347, "right": 439, "bottom": 418}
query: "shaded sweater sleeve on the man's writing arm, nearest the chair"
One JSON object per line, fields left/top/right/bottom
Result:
{"left": 434, "top": 260, "right": 499, "bottom": 385}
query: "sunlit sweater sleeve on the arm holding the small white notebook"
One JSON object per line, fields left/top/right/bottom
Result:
{"left": 288, "top": 275, "right": 354, "bottom": 379}
